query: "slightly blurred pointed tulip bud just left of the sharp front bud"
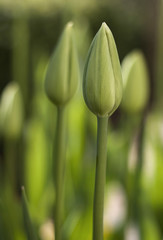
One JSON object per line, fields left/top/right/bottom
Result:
{"left": 45, "top": 22, "right": 79, "bottom": 106}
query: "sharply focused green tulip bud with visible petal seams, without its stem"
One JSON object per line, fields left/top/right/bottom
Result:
{"left": 83, "top": 23, "right": 122, "bottom": 117}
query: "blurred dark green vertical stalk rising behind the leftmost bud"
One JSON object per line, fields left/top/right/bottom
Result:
{"left": 12, "top": 14, "right": 30, "bottom": 114}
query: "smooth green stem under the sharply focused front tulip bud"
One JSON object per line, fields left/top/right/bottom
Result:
{"left": 93, "top": 117, "right": 108, "bottom": 240}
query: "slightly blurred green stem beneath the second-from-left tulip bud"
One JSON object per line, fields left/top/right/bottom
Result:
{"left": 54, "top": 107, "right": 66, "bottom": 240}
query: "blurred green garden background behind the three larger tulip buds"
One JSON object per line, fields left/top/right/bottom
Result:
{"left": 0, "top": 0, "right": 163, "bottom": 240}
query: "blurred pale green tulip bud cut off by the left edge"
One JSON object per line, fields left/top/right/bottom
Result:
{"left": 0, "top": 82, "right": 24, "bottom": 139}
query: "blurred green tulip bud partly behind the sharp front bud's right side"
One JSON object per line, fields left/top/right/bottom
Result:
{"left": 122, "top": 50, "right": 150, "bottom": 113}
